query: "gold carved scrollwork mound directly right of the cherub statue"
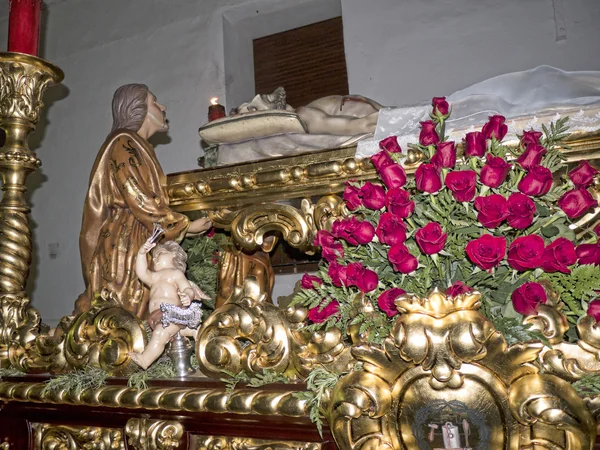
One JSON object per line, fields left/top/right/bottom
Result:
{"left": 196, "top": 277, "right": 291, "bottom": 377}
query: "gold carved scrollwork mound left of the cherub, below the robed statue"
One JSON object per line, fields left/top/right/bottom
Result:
{"left": 64, "top": 290, "right": 146, "bottom": 375}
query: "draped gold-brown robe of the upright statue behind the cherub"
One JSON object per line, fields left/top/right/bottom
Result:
{"left": 74, "top": 130, "right": 189, "bottom": 319}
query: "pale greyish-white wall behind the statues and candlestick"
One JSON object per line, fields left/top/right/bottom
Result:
{"left": 0, "top": 0, "right": 600, "bottom": 324}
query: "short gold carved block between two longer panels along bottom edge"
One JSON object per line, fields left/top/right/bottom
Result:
{"left": 125, "top": 419, "right": 184, "bottom": 450}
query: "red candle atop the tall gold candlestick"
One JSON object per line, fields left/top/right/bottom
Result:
{"left": 8, "top": 0, "right": 42, "bottom": 56}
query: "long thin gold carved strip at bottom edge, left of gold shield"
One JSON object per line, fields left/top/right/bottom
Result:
{"left": 190, "top": 436, "right": 322, "bottom": 450}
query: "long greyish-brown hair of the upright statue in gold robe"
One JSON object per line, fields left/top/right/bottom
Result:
{"left": 112, "top": 83, "right": 149, "bottom": 132}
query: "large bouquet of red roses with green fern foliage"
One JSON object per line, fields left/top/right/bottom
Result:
{"left": 294, "top": 97, "right": 600, "bottom": 342}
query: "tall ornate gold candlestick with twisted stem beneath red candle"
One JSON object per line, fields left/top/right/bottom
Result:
{"left": 0, "top": 53, "right": 64, "bottom": 365}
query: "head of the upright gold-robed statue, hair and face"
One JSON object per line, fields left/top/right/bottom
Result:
{"left": 112, "top": 83, "right": 169, "bottom": 134}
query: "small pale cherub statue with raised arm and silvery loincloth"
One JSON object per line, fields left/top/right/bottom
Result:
{"left": 129, "top": 225, "right": 210, "bottom": 369}
